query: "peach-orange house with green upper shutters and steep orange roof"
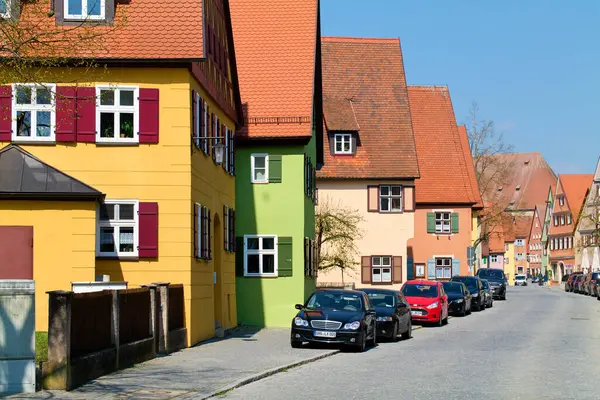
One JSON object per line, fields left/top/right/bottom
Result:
{"left": 408, "top": 86, "right": 483, "bottom": 280}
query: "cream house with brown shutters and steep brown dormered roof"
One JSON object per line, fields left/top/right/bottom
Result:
{"left": 317, "top": 37, "right": 425, "bottom": 288}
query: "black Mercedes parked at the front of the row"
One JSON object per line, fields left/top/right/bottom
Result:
{"left": 290, "top": 289, "right": 377, "bottom": 351}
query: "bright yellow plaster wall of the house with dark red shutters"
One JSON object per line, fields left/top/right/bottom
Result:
{"left": 0, "top": 68, "right": 237, "bottom": 344}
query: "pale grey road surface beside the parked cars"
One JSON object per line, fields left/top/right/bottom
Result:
{"left": 221, "top": 286, "right": 600, "bottom": 400}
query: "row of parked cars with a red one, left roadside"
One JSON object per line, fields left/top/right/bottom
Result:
{"left": 290, "top": 269, "right": 506, "bottom": 352}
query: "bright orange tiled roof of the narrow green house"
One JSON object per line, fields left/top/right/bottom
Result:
{"left": 230, "top": 0, "right": 318, "bottom": 138}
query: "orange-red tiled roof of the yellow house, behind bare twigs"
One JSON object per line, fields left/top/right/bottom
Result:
{"left": 14, "top": 0, "right": 205, "bottom": 60}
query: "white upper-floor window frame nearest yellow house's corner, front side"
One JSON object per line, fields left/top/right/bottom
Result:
{"left": 96, "top": 85, "right": 140, "bottom": 144}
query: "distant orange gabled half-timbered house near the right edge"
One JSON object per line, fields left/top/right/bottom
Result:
{"left": 548, "top": 174, "right": 594, "bottom": 282}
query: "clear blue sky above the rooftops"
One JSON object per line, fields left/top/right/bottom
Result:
{"left": 321, "top": 0, "right": 600, "bottom": 173}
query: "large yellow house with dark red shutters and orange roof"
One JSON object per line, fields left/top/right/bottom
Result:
{"left": 0, "top": 0, "right": 242, "bottom": 344}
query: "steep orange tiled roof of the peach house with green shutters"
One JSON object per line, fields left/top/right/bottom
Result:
{"left": 408, "top": 86, "right": 476, "bottom": 204}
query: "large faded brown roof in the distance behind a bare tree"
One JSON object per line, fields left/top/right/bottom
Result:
{"left": 481, "top": 153, "right": 556, "bottom": 211}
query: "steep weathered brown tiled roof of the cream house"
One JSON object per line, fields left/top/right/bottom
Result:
{"left": 316, "top": 37, "right": 419, "bottom": 179}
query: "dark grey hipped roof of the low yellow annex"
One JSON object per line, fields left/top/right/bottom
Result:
{"left": 0, "top": 144, "right": 103, "bottom": 199}
